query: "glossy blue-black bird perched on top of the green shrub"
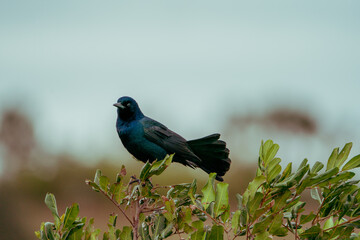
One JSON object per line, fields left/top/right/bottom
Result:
{"left": 114, "top": 97, "right": 231, "bottom": 181}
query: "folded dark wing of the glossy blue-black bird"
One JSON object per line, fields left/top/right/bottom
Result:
{"left": 141, "top": 117, "right": 201, "bottom": 167}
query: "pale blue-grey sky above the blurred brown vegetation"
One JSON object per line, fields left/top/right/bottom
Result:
{"left": 0, "top": 0, "right": 360, "bottom": 163}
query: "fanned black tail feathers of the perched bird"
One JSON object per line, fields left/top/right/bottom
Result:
{"left": 187, "top": 134, "right": 231, "bottom": 181}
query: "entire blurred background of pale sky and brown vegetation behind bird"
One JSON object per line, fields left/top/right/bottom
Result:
{"left": 0, "top": 0, "right": 360, "bottom": 239}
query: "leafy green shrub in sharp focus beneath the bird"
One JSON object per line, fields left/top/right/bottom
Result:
{"left": 36, "top": 140, "right": 360, "bottom": 240}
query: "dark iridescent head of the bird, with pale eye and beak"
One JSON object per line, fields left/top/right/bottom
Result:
{"left": 113, "top": 97, "right": 144, "bottom": 121}
